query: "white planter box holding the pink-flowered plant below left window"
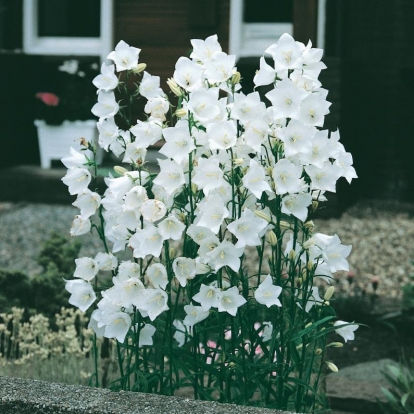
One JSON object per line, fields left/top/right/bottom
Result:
{"left": 34, "top": 120, "right": 104, "bottom": 169}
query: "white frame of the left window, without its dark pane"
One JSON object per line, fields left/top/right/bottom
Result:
{"left": 23, "top": 0, "right": 113, "bottom": 61}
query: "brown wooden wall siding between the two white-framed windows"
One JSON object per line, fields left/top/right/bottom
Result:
{"left": 115, "top": 0, "right": 230, "bottom": 87}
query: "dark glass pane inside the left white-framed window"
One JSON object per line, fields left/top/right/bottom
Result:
{"left": 38, "top": 0, "right": 101, "bottom": 37}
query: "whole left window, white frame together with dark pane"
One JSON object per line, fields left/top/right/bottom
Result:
{"left": 23, "top": 0, "right": 113, "bottom": 60}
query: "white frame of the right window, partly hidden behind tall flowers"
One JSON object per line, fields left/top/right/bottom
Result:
{"left": 229, "top": 0, "right": 326, "bottom": 59}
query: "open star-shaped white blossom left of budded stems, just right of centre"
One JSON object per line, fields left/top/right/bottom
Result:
{"left": 227, "top": 208, "right": 268, "bottom": 247}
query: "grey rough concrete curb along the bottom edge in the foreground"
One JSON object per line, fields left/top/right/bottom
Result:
{"left": 0, "top": 377, "right": 298, "bottom": 414}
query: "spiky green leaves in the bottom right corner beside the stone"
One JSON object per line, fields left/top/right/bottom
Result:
{"left": 380, "top": 359, "right": 414, "bottom": 414}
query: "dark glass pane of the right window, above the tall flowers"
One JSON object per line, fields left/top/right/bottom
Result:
{"left": 244, "top": 0, "right": 293, "bottom": 23}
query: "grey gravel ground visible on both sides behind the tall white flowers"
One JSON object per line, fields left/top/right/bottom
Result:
{"left": 0, "top": 201, "right": 414, "bottom": 298}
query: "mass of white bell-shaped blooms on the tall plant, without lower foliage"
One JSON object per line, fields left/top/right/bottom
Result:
{"left": 63, "top": 34, "right": 356, "bottom": 345}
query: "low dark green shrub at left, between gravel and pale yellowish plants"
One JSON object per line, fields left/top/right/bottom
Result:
{"left": 0, "top": 233, "right": 80, "bottom": 318}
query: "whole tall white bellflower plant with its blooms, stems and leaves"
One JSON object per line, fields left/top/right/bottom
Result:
{"left": 62, "top": 34, "right": 356, "bottom": 412}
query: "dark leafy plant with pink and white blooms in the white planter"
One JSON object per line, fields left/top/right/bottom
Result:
{"left": 35, "top": 59, "right": 99, "bottom": 125}
